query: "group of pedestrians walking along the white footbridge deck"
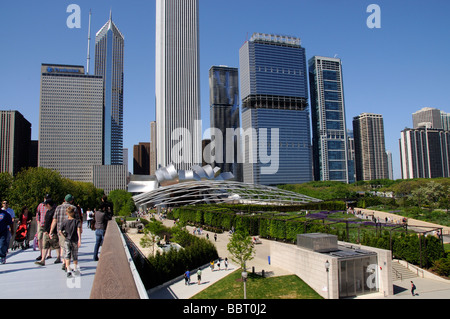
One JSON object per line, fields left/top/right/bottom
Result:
{"left": 0, "top": 194, "right": 113, "bottom": 278}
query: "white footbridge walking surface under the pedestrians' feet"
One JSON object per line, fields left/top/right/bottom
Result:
{"left": 0, "top": 224, "right": 97, "bottom": 300}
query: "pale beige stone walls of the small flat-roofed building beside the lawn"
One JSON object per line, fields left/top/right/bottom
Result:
{"left": 270, "top": 241, "right": 393, "bottom": 299}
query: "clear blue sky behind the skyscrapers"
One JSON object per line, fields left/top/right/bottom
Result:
{"left": 0, "top": 0, "right": 450, "bottom": 178}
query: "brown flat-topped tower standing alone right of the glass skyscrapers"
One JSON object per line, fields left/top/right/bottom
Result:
{"left": 353, "top": 113, "right": 389, "bottom": 181}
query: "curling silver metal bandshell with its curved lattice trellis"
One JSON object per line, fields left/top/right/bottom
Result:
{"left": 129, "top": 165, "right": 321, "bottom": 207}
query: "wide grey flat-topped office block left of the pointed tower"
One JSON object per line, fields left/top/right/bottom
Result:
{"left": 38, "top": 64, "right": 103, "bottom": 182}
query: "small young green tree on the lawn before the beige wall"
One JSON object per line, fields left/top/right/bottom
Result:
{"left": 227, "top": 229, "right": 255, "bottom": 270}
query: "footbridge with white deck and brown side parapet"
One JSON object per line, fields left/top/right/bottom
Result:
{"left": 0, "top": 220, "right": 148, "bottom": 300}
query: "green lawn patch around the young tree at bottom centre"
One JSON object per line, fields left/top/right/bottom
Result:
{"left": 192, "top": 269, "right": 323, "bottom": 299}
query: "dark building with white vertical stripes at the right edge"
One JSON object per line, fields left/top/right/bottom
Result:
{"left": 399, "top": 127, "right": 450, "bottom": 179}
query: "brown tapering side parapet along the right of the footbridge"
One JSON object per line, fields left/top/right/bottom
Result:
{"left": 90, "top": 220, "right": 147, "bottom": 299}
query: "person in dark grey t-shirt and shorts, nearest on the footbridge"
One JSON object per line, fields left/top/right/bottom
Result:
{"left": 61, "top": 207, "right": 81, "bottom": 278}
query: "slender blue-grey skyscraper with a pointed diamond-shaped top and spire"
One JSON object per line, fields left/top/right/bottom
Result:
{"left": 95, "top": 14, "right": 125, "bottom": 165}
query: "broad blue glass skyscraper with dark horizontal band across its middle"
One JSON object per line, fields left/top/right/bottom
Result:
{"left": 239, "top": 33, "right": 312, "bottom": 185}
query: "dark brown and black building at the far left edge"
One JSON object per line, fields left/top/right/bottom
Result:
{"left": 0, "top": 111, "right": 33, "bottom": 176}
